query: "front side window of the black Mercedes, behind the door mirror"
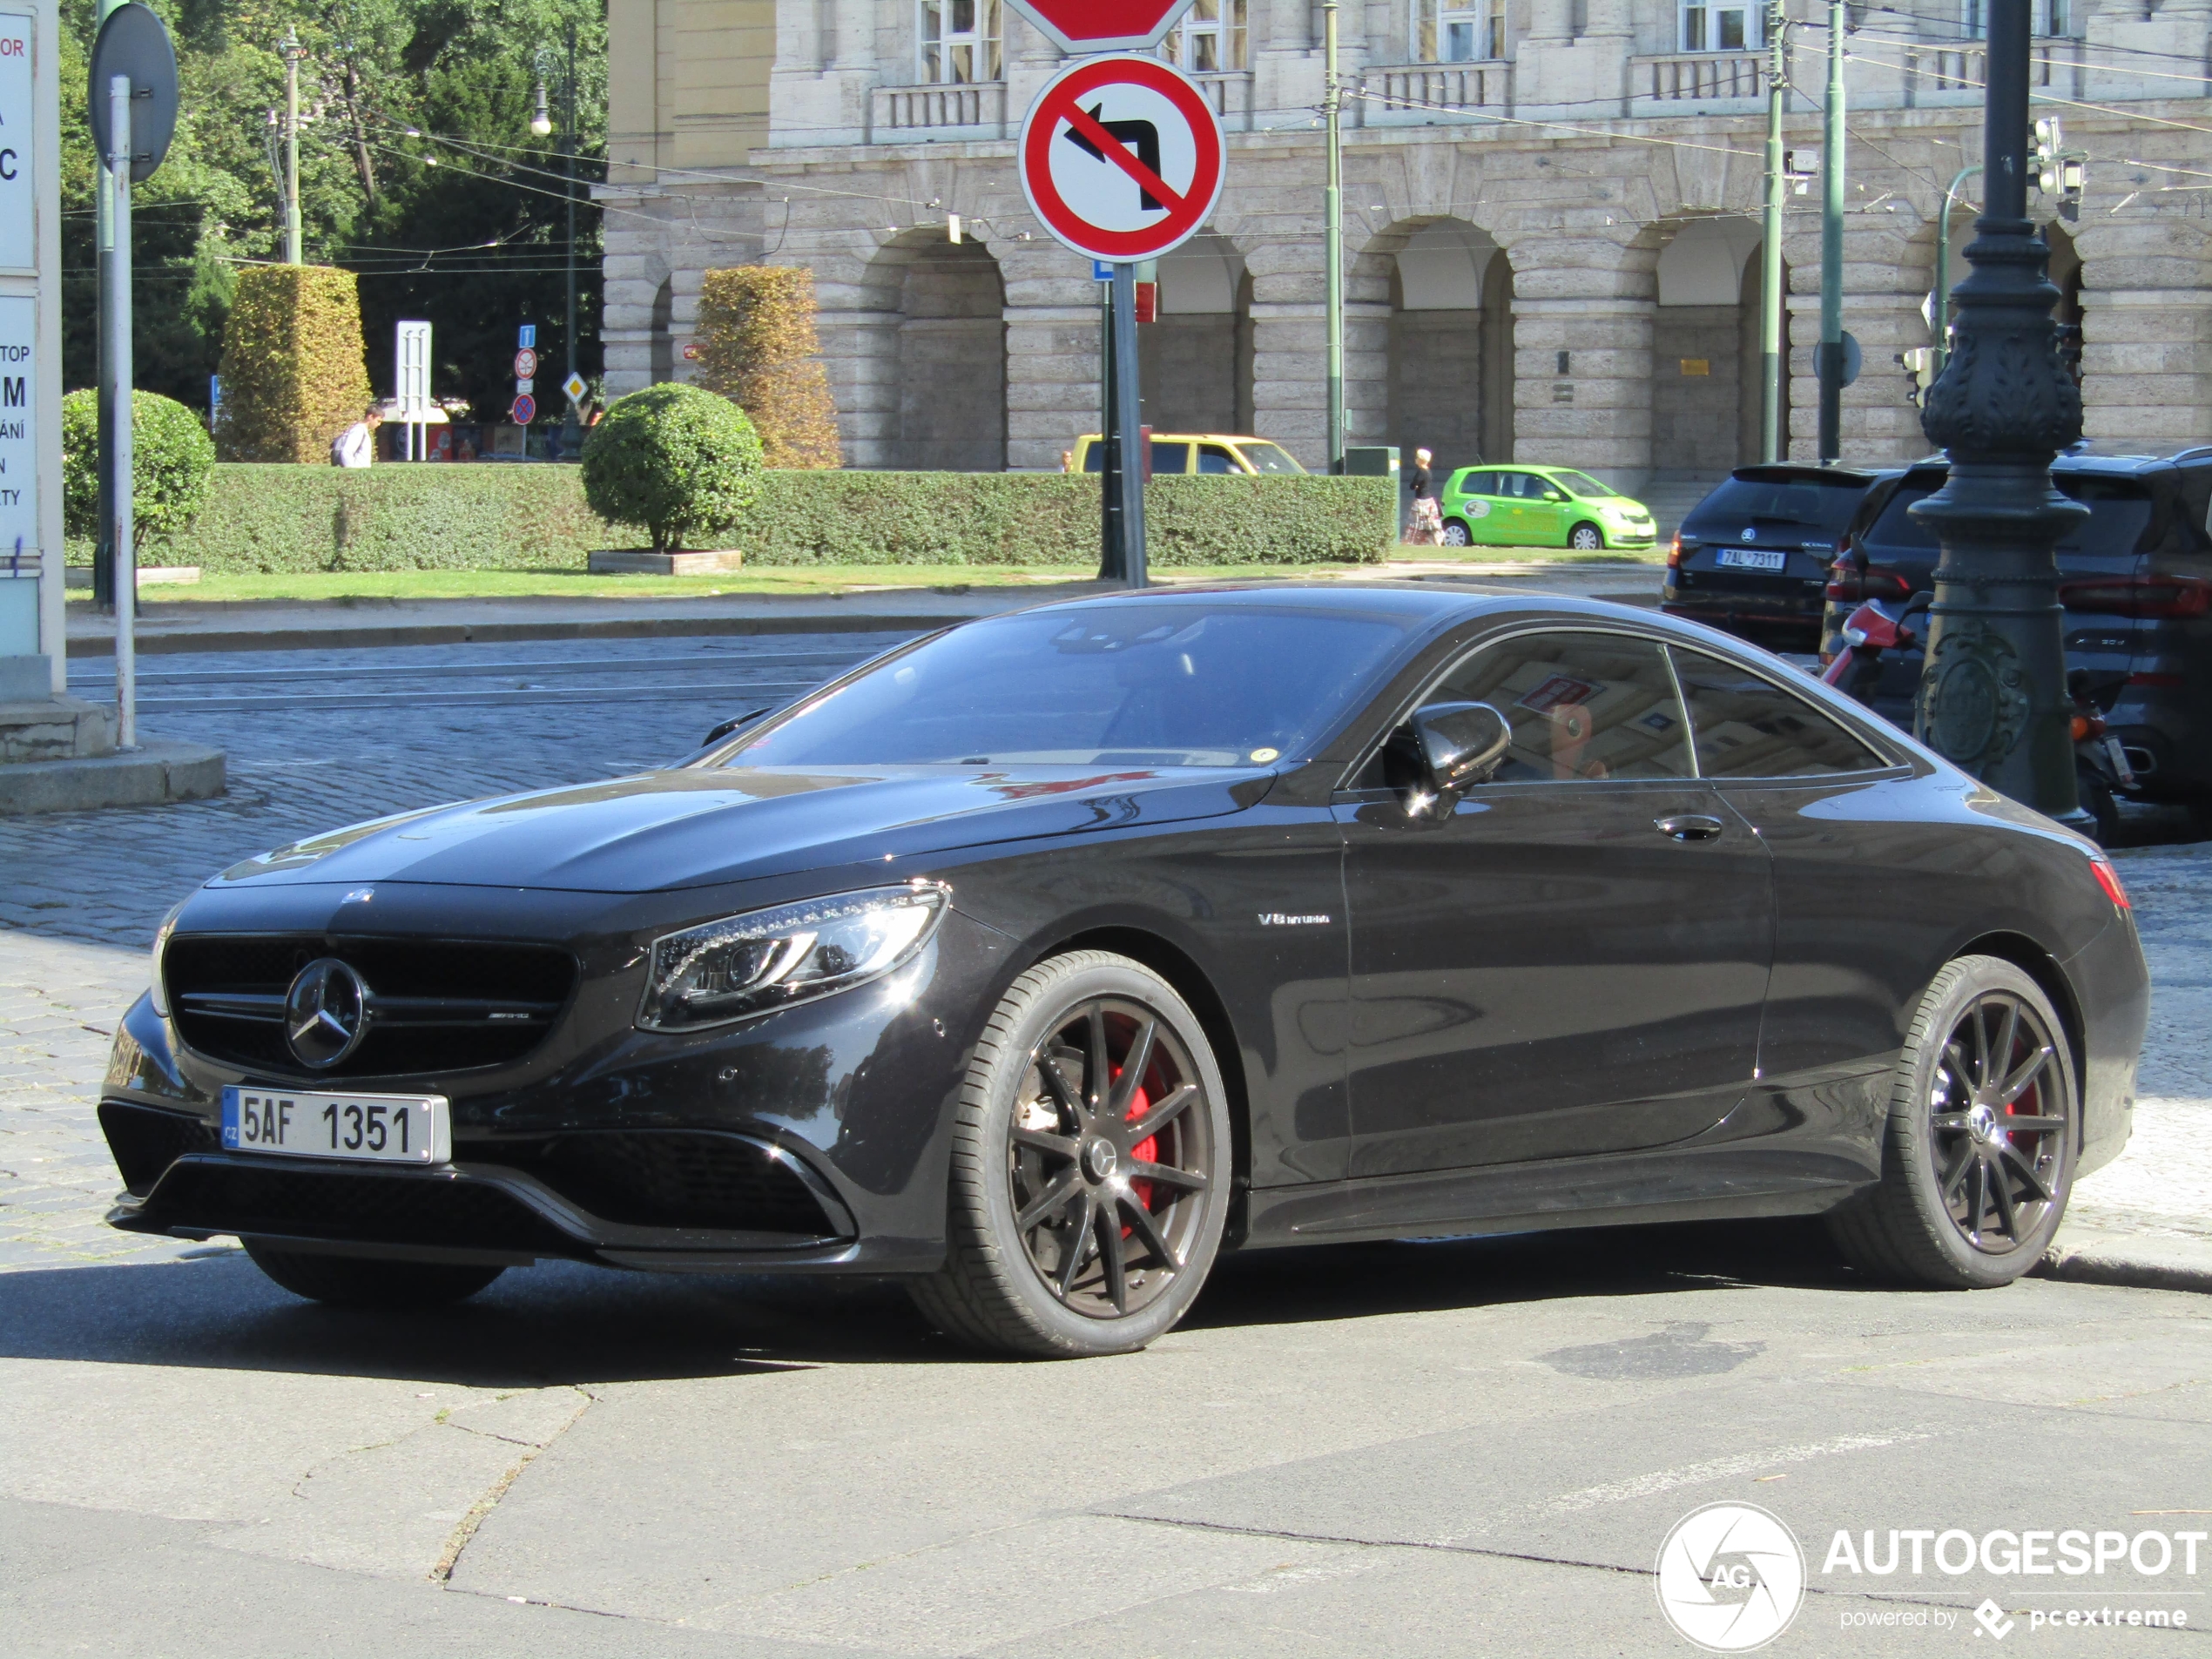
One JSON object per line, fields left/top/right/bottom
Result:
{"left": 1422, "top": 632, "right": 1692, "bottom": 783}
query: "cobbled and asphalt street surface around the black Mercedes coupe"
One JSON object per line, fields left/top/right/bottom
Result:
{"left": 0, "top": 619, "right": 2212, "bottom": 1659}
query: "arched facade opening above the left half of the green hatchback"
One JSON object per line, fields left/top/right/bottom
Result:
{"left": 1345, "top": 219, "right": 1513, "bottom": 478}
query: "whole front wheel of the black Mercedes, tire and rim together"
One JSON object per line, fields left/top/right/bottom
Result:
{"left": 909, "top": 951, "right": 1230, "bottom": 1359}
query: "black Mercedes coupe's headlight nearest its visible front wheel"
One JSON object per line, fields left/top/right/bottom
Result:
{"left": 637, "top": 880, "right": 951, "bottom": 1031}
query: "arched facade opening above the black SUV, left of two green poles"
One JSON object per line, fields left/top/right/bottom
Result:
{"left": 1652, "top": 214, "right": 1790, "bottom": 482}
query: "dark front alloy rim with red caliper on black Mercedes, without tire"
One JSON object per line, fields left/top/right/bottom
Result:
{"left": 1007, "top": 998, "right": 1217, "bottom": 1318}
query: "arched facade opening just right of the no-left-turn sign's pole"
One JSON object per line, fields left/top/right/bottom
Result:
{"left": 1137, "top": 230, "right": 1252, "bottom": 434}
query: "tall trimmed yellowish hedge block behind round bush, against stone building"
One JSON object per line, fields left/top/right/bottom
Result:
{"left": 692, "top": 266, "right": 845, "bottom": 469}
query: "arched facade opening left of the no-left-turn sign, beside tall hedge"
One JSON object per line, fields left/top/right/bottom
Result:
{"left": 840, "top": 228, "right": 1007, "bottom": 474}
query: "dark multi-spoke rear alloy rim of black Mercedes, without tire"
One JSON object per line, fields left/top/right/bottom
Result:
{"left": 1929, "top": 991, "right": 2068, "bottom": 1254}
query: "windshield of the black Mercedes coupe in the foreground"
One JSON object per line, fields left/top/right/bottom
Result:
{"left": 721, "top": 599, "right": 1412, "bottom": 767}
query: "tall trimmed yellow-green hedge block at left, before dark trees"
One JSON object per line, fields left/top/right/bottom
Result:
{"left": 214, "top": 266, "right": 369, "bottom": 462}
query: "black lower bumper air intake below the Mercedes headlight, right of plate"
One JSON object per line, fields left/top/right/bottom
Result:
{"left": 493, "top": 1130, "right": 836, "bottom": 1238}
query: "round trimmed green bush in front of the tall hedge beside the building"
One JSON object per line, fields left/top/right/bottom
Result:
{"left": 584, "top": 381, "right": 761, "bottom": 553}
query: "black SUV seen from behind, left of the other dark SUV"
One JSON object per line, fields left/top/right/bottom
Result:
{"left": 1659, "top": 462, "right": 1878, "bottom": 651}
